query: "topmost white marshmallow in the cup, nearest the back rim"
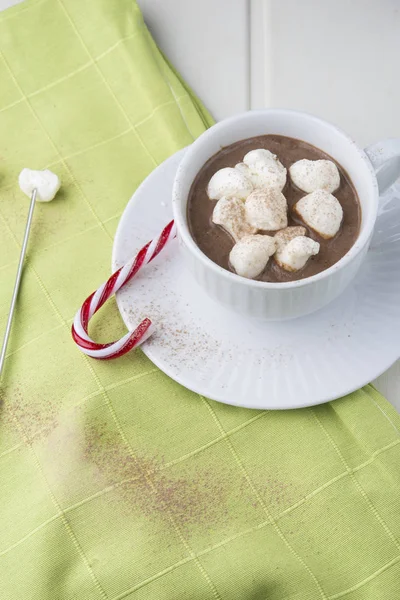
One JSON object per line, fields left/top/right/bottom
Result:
{"left": 241, "top": 148, "right": 286, "bottom": 190}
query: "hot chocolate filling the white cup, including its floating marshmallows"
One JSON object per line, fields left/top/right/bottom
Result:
{"left": 188, "top": 135, "right": 361, "bottom": 282}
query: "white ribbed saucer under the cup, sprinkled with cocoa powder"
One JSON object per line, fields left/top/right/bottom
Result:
{"left": 112, "top": 150, "right": 400, "bottom": 409}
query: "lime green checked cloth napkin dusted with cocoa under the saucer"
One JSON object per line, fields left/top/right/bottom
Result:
{"left": 0, "top": 0, "right": 400, "bottom": 600}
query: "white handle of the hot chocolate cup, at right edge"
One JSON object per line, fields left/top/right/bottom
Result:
{"left": 365, "top": 138, "right": 400, "bottom": 195}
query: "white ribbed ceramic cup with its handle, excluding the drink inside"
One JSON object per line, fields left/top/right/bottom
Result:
{"left": 173, "top": 109, "right": 400, "bottom": 320}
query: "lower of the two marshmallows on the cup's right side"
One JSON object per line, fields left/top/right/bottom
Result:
{"left": 293, "top": 190, "right": 343, "bottom": 239}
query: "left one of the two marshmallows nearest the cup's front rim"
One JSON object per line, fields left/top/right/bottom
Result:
{"left": 229, "top": 235, "right": 276, "bottom": 279}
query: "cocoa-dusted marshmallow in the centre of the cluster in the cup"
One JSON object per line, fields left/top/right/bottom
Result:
{"left": 245, "top": 188, "right": 287, "bottom": 231}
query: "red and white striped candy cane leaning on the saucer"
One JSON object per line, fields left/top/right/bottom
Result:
{"left": 71, "top": 221, "right": 176, "bottom": 360}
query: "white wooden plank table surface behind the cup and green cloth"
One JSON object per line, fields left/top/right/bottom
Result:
{"left": 0, "top": 0, "right": 400, "bottom": 411}
